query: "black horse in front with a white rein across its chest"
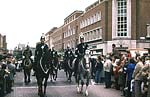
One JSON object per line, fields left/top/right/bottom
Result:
{"left": 35, "top": 51, "right": 50, "bottom": 97}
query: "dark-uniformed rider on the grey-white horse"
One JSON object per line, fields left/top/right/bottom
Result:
{"left": 74, "top": 35, "right": 88, "bottom": 77}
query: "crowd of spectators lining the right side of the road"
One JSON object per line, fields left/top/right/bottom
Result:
{"left": 91, "top": 44, "right": 150, "bottom": 97}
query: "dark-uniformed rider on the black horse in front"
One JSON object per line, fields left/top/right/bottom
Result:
{"left": 33, "top": 36, "right": 48, "bottom": 71}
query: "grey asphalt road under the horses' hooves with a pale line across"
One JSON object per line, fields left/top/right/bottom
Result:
{"left": 5, "top": 70, "right": 122, "bottom": 97}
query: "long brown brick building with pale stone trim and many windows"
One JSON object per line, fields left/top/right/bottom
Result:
{"left": 45, "top": 0, "right": 150, "bottom": 55}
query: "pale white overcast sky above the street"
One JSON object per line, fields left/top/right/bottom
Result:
{"left": 0, "top": 0, "right": 97, "bottom": 50}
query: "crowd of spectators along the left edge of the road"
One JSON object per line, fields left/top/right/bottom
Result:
{"left": 0, "top": 54, "right": 16, "bottom": 96}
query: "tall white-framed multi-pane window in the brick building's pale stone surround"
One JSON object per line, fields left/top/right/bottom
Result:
{"left": 117, "top": 0, "right": 127, "bottom": 37}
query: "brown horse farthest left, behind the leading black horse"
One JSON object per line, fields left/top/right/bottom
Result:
{"left": 23, "top": 57, "right": 32, "bottom": 84}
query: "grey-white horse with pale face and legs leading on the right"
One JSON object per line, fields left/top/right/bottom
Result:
{"left": 73, "top": 50, "right": 91, "bottom": 96}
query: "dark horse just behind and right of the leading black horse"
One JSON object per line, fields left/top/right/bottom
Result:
{"left": 50, "top": 57, "right": 59, "bottom": 82}
